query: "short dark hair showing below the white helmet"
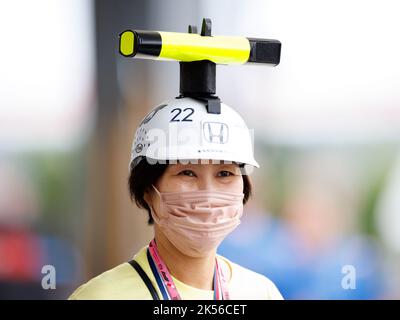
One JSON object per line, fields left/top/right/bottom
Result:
{"left": 128, "top": 159, "right": 252, "bottom": 225}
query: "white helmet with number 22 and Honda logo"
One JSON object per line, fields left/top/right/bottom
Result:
{"left": 129, "top": 97, "right": 259, "bottom": 169}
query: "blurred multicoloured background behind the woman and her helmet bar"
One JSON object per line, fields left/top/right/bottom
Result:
{"left": 0, "top": 0, "right": 400, "bottom": 299}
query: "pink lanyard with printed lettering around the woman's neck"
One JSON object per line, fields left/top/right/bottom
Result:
{"left": 149, "top": 239, "right": 229, "bottom": 300}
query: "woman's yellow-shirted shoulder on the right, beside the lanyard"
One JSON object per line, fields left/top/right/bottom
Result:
{"left": 219, "top": 256, "right": 283, "bottom": 300}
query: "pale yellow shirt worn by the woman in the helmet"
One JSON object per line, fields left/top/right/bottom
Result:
{"left": 69, "top": 246, "right": 283, "bottom": 300}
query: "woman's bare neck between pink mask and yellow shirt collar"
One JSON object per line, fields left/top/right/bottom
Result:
{"left": 155, "top": 226, "right": 216, "bottom": 290}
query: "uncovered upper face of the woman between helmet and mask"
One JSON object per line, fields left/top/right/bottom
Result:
{"left": 145, "top": 163, "right": 243, "bottom": 204}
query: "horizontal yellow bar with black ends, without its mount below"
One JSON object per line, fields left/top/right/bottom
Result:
{"left": 119, "top": 26, "right": 281, "bottom": 66}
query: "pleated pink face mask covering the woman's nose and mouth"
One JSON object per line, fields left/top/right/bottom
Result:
{"left": 151, "top": 186, "right": 244, "bottom": 257}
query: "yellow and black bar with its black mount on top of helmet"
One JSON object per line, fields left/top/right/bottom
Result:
{"left": 119, "top": 19, "right": 281, "bottom": 113}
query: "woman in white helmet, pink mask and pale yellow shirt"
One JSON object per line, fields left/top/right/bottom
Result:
{"left": 70, "top": 98, "right": 282, "bottom": 300}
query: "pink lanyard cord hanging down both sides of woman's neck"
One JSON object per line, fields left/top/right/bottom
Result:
{"left": 147, "top": 239, "right": 229, "bottom": 300}
